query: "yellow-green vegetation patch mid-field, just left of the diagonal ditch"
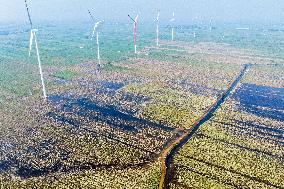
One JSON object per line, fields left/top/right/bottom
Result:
{"left": 125, "top": 83, "right": 214, "bottom": 128}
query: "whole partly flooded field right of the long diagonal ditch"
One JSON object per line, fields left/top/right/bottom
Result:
{"left": 171, "top": 65, "right": 284, "bottom": 188}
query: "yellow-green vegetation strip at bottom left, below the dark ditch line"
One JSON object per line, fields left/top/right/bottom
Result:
{"left": 1, "top": 163, "right": 160, "bottom": 189}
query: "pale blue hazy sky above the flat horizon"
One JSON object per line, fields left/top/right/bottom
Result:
{"left": 0, "top": 0, "right": 284, "bottom": 23}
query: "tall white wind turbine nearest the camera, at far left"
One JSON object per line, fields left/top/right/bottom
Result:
{"left": 25, "top": 0, "right": 47, "bottom": 100}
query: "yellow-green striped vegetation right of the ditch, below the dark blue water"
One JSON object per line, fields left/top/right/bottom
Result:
{"left": 174, "top": 107, "right": 284, "bottom": 188}
